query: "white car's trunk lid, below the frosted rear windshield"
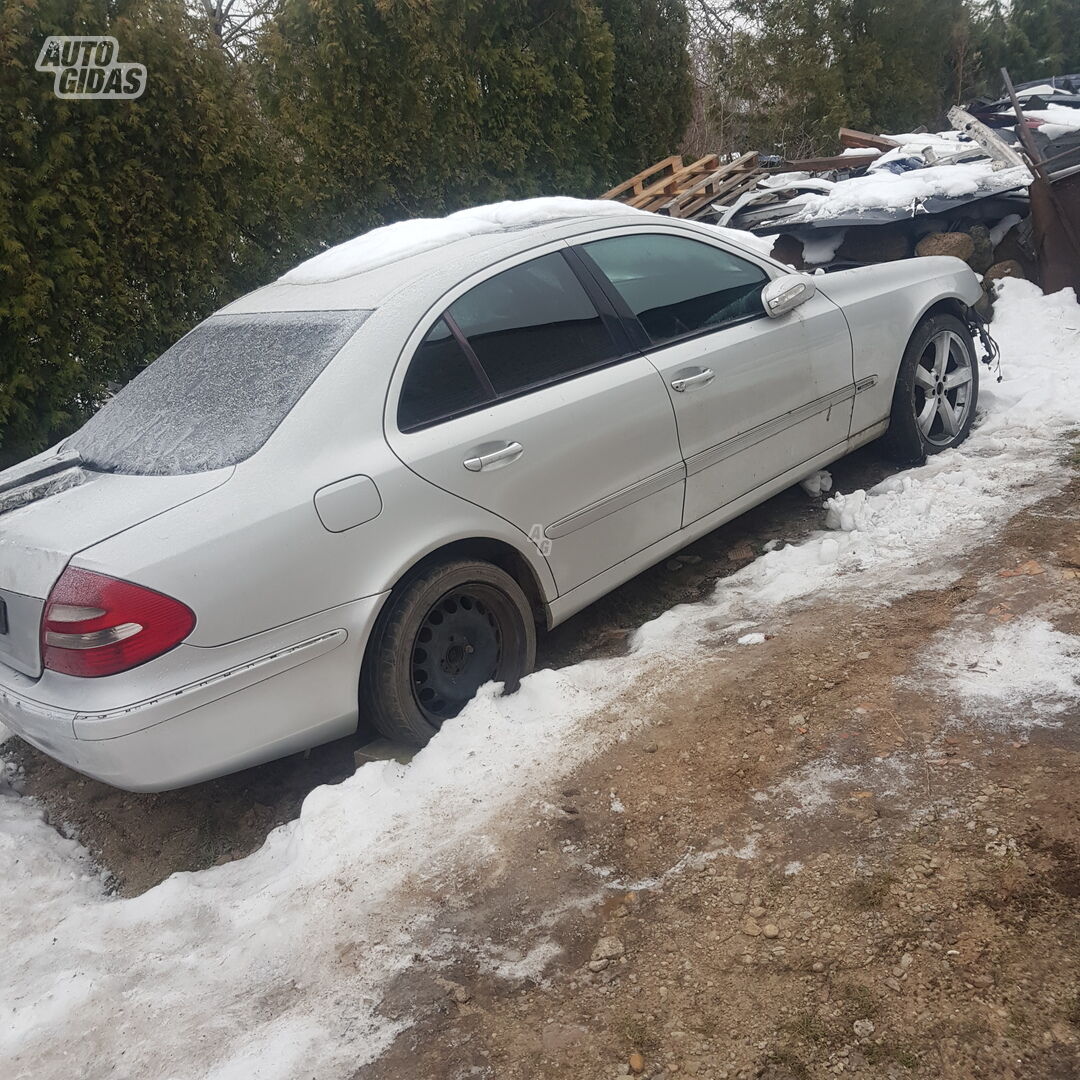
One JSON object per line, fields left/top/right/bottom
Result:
{"left": 0, "top": 451, "right": 233, "bottom": 678}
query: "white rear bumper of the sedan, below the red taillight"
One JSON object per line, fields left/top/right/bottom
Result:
{"left": 0, "top": 596, "right": 383, "bottom": 792}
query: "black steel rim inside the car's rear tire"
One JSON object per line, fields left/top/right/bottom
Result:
{"left": 409, "top": 582, "right": 515, "bottom": 727}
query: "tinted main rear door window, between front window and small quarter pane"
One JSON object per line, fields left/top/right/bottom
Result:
{"left": 449, "top": 253, "right": 619, "bottom": 396}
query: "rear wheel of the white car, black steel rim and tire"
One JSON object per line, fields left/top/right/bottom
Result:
{"left": 360, "top": 559, "right": 537, "bottom": 746}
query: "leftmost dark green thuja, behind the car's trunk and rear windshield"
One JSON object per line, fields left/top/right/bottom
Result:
{"left": 0, "top": 0, "right": 283, "bottom": 461}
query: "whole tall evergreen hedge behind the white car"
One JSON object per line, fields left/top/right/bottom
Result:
{"left": 0, "top": 0, "right": 689, "bottom": 464}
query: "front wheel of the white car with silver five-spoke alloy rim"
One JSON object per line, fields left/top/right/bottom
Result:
{"left": 882, "top": 314, "right": 978, "bottom": 464}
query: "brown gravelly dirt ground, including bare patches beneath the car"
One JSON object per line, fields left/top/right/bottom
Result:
{"left": 4, "top": 458, "right": 1080, "bottom": 1080}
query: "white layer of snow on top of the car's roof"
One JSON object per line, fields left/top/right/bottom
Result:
{"left": 278, "top": 198, "right": 645, "bottom": 285}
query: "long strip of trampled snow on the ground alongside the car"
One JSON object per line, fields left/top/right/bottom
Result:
{"left": 0, "top": 281, "right": 1080, "bottom": 1080}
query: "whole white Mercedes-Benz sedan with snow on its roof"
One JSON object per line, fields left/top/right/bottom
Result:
{"left": 0, "top": 200, "right": 981, "bottom": 791}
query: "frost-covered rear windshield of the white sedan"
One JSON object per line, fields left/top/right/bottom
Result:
{"left": 64, "top": 311, "right": 370, "bottom": 476}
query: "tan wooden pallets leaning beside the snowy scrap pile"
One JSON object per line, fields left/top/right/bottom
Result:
{"left": 600, "top": 153, "right": 765, "bottom": 217}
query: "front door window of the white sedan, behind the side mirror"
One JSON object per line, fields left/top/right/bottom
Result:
{"left": 581, "top": 232, "right": 768, "bottom": 345}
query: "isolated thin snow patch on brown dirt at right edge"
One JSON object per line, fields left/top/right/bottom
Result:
{"left": 919, "top": 617, "right": 1080, "bottom": 729}
